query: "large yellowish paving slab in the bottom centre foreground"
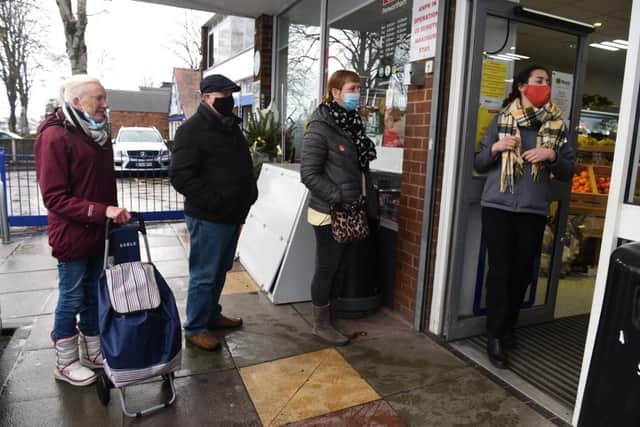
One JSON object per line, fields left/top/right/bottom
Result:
{"left": 240, "top": 348, "right": 380, "bottom": 426}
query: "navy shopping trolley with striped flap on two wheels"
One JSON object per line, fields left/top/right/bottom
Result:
{"left": 96, "top": 212, "right": 182, "bottom": 417}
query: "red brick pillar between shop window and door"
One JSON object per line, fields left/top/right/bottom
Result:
{"left": 393, "top": 2, "right": 455, "bottom": 323}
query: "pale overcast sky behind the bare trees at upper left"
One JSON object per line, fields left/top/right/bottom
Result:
{"left": 0, "top": 0, "right": 212, "bottom": 128}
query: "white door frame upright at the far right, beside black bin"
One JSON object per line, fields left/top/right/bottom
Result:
{"left": 573, "top": 1, "right": 640, "bottom": 425}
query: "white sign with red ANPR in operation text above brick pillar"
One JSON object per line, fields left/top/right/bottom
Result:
{"left": 409, "top": 0, "right": 438, "bottom": 62}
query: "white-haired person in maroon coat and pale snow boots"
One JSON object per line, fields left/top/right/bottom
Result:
{"left": 34, "top": 74, "right": 131, "bottom": 386}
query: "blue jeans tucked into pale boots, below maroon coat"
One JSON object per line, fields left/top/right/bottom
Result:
{"left": 53, "top": 256, "right": 103, "bottom": 340}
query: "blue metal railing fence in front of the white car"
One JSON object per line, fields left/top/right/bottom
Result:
{"left": 0, "top": 144, "right": 184, "bottom": 227}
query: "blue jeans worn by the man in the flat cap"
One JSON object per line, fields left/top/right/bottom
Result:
{"left": 184, "top": 215, "right": 240, "bottom": 335}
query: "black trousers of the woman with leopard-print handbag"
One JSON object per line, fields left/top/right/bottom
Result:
{"left": 311, "top": 225, "right": 356, "bottom": 306}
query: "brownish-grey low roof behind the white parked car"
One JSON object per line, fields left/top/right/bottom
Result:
{"left": 107, "top": 88, "right": 170, "bottom": 113}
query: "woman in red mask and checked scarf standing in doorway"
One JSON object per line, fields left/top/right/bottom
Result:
{"left": 474, "top": 65, "right": 575, "bottom": 368}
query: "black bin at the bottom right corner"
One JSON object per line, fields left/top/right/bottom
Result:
{"left": 578, "top": 242, "right": 640, "bottom": 427}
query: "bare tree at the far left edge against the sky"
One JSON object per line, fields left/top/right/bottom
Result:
{"left": 0, "top": 0, "right": 42, "bottom": 133}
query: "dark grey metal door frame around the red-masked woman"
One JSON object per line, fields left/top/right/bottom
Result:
{"left": 439, "top": 0, "right": 592, "bottom": 340}
